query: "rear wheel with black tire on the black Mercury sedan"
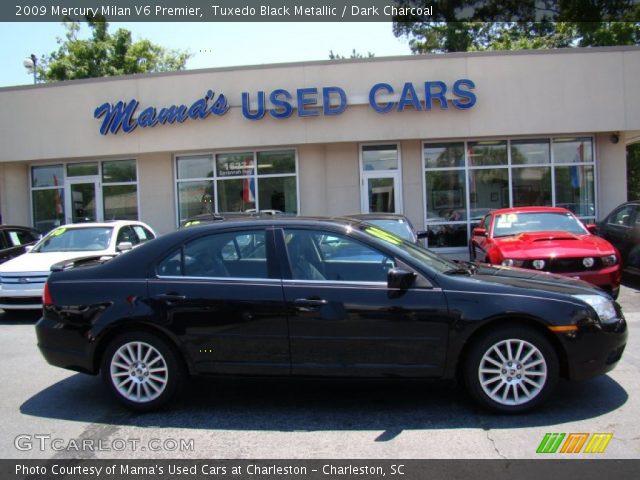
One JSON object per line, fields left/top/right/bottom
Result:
{"left": 101, "top": 332, "right": 185, "bottom": 412}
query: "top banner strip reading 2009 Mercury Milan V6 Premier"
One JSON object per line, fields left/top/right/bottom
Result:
{"left": 5, "top": 0, "right": 640, "bottom": 23}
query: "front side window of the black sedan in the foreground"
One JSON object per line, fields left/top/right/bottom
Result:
{"left": 285, "top": 229, "right": 396, "bottom": 282}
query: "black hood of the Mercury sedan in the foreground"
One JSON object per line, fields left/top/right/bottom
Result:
{"left": 471, "top": 264, "right": 603, "bottom": 295}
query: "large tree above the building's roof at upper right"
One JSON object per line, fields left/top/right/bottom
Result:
{"left": 393, "top": 0, "right": 640, "bottom": 53}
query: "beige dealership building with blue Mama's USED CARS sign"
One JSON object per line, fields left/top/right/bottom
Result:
{"left": 0, "top": 47, "right": 640, "bottom": 255}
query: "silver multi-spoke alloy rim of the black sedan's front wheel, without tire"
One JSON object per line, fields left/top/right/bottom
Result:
{"left": 478, "top": 339, "right": 547, "bottom": 405}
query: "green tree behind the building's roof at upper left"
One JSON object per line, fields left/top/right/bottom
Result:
{"left": 37, "top": 17, "right": 191, "bottom": 82}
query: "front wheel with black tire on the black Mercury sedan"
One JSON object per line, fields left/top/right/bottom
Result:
{"left": 463, "top": 326, "right": 559, "bottom": 413}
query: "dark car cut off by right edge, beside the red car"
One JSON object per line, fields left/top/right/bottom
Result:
{"left": 598, "top": 201, "right": 640, "bottom": 274}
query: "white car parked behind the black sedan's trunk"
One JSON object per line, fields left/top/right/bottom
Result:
{"left": 0, "top": 220, "right": 156, "bottom": 310}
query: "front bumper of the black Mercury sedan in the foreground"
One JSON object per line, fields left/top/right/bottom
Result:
{"left": 558, "top": 318, "right": 629, "bottom": 380}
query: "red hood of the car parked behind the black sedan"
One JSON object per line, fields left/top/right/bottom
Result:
{"left": 494, "top": 232, "right": 615, "bottom": 259}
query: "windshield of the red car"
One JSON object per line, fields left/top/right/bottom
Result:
{"left": 493, "top": 212, "right": 587, "bottom": 238}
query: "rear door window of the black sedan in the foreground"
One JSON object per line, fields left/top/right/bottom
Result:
{"left": 183, "top": 230, "right": 269, "bottom": 278}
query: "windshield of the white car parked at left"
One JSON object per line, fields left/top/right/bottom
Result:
{"left": 32, "top": 227, "right": 113, "bottom": 253}
